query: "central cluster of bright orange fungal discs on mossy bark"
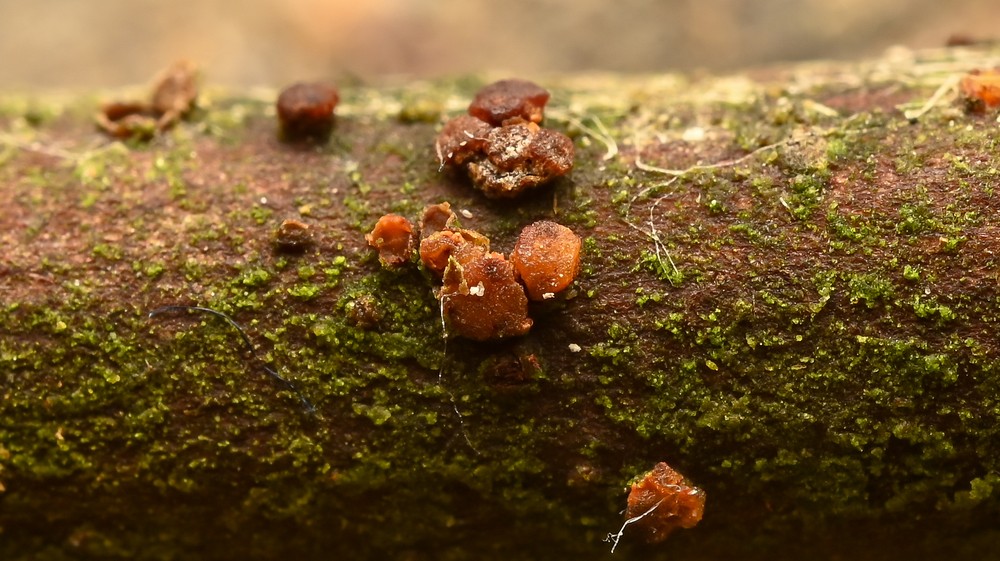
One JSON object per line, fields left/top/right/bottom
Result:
{"left": 367, "top": 203, "right": 582, "bottom": 341}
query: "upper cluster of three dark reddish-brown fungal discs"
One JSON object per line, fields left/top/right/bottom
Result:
{"left": 435, "top": 80, "right": 575, "bottom": 198}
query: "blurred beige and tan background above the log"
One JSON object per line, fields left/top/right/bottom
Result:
{"left": 0, "top": 0, "right": 1000, "bottom": 89}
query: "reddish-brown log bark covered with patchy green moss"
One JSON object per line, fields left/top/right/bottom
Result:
{"left": 0, "top": 50, "right": 1000, "bottom": 559}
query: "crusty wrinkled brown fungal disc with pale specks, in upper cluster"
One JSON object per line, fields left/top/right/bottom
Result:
{"left": 467, "top": 123, "right": 575, "bottom": 198}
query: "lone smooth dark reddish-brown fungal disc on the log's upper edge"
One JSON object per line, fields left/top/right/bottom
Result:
{"left": 276, "top": 82, "right": 340, "bottom": 140}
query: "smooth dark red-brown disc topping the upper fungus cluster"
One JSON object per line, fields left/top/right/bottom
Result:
{"left": 469, "top": 80, "right": 549, "bottom": 127}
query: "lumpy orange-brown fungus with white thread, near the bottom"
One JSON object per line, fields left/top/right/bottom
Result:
{"left": 625, "top": 462, "right": 705, "bottom": 543}
